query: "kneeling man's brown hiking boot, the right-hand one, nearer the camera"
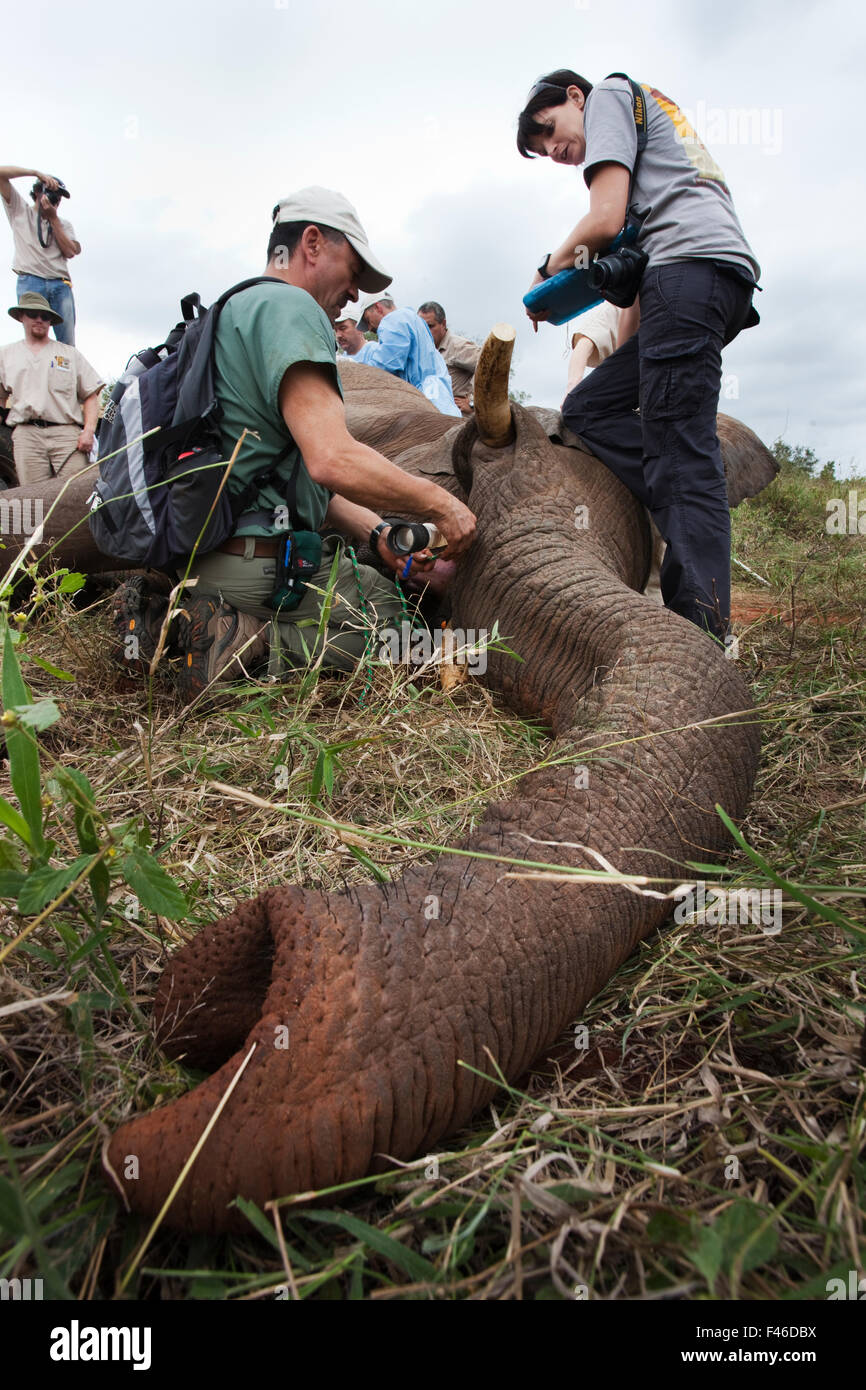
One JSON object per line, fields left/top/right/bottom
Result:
{"left": 175, "top": 594, "right": 270, "bottom": 705}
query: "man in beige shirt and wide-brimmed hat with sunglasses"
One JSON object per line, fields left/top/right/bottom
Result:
{"left": 0, "top": 292, "right": 104, "bottom": 488}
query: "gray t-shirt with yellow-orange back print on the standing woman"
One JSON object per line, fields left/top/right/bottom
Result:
{"left": 584, "top": 78, "right": 760, "bottom": 282}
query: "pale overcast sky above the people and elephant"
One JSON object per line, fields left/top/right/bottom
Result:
{"left": 0, "top": 0, "right": 866, "bottom": 473}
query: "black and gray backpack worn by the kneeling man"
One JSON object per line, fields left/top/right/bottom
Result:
{"left": 89, "top": 275, "right": 292, "bottom": 570}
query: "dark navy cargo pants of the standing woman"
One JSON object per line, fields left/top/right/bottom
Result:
{"left": 563, "top": 260, "right": 756, "bottom": 641}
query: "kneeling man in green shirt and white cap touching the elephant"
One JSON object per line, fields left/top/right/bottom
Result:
{"left": 115, "top": 186, "right": 475, "bottom": 701}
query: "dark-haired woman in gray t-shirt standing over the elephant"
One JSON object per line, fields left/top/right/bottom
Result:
{"left": 517, "top": 68, "right": 760, "bottom": 641}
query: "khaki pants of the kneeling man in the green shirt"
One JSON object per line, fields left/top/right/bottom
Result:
{"left": 189, "top": 537, "right": 403, "bottom": 676}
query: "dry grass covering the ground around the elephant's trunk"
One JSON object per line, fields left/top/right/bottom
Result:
{"left": 0, "top": 500, "right": 866, "bottom": 1300}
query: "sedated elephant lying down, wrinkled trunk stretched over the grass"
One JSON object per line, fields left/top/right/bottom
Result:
{"left": 1, "top": 331, "right": 773, "bottom": 1232}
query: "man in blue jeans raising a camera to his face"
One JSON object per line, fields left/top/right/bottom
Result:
{"left": 0, "top": 164, "right": 81, "bottom": 346}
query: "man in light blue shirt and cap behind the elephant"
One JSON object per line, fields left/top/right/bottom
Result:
{"left": 357, "top": 286, "right": 460, "bottom": 420}
